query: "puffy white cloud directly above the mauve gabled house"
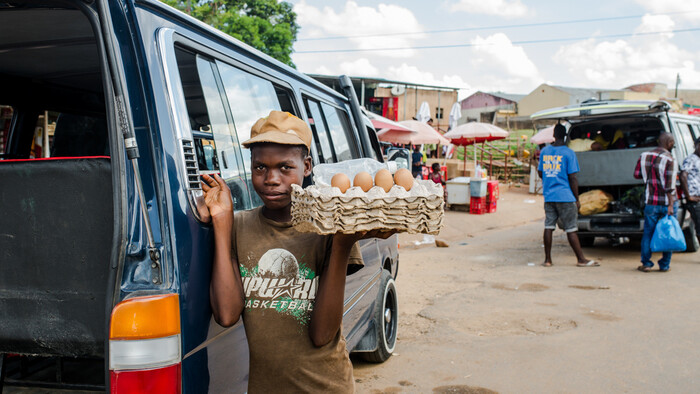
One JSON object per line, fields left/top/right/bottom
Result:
{"left": 471, "top": 33, "right": 543, "bottom": 83}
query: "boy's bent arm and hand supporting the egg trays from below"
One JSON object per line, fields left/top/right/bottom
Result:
{"left": 309, "top": 231, "right": 394, "bottom": 347}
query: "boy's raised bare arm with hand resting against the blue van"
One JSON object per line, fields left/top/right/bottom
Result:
{"left": 202, "top": 175, "right": 244, "bottom": 327}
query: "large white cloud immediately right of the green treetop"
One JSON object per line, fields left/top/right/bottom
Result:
{"left": 294, "top": 0, "right": 425, "bottom": 57}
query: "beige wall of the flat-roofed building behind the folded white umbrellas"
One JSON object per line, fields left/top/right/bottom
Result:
{"left": 374, "top": 87, "right": 457, "bottom": 130}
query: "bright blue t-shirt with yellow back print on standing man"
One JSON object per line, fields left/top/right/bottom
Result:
{"left": 537, "top": 145, "right": 579, "bottom": 202}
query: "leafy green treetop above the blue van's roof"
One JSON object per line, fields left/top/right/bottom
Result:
{"left": 161, "top": 0, "right": 299, "bottom": 67}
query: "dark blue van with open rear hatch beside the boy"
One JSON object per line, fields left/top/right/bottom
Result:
{"left": 0, "top": 0, "right": 398, "bottom": 393}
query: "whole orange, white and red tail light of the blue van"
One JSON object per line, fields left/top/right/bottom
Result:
{"left": 109, "top": 294, "right": 182, "bottom": 394}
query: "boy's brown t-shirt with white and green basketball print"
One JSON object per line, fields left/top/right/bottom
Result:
{"left": 232, "top": 208, "right": 362, "bottom": 393}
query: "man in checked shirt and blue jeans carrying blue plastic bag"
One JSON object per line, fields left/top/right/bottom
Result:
{"left": 634, "top": 133, "right": 678, "bottom": 272}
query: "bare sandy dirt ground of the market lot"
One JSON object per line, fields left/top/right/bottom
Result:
{"left": 353, "top": 187, "right": 700, "bottom": 393}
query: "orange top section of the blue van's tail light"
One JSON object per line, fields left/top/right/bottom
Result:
{"left": 109, "top": 294, "right": 180, "bottom": 339}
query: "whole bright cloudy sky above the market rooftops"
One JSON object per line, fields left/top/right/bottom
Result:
{"left": 288, "top": 0, "right": 700, "bottom": 97}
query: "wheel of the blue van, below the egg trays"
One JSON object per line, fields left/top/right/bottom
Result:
{"left": 362, "top": 270, "right": 399, "bottom": 363}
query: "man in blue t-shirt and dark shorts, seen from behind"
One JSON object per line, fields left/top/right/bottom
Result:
{"left": 537, "top": 124, "right": 600, "bottom": 267}
